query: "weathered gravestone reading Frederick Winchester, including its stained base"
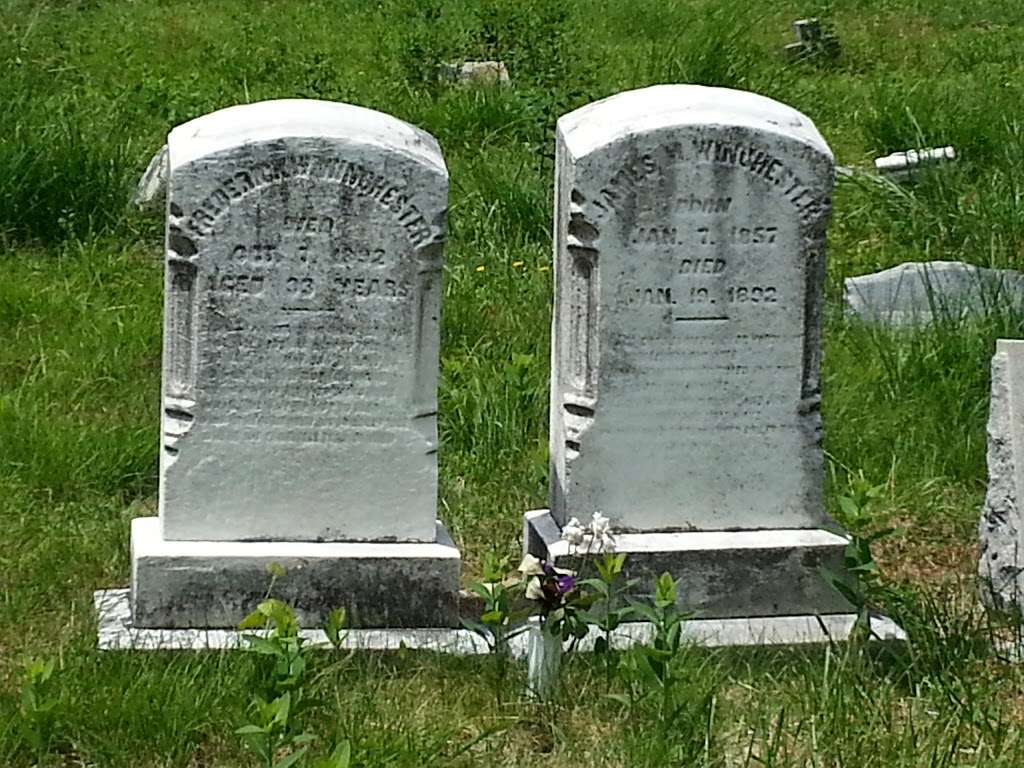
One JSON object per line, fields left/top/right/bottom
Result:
{"left": 132, "top": 100, "right": 459, "bottom": 627}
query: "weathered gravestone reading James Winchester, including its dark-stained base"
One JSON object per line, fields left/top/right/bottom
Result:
{"left": 526, "top": 85, "right": 849, "bottom": 616}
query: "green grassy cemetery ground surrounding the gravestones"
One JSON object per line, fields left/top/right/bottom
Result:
{"left": 0, "top": 0, "right": 1024, "bottom": 768}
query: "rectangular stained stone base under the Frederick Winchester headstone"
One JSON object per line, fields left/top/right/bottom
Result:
{"left": 131, "top": 517, "right": 460, "bottom": 629}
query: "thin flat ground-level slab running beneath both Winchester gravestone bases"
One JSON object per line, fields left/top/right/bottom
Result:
{"left": 93, "top": 589, "right": 906, "bottom": 658}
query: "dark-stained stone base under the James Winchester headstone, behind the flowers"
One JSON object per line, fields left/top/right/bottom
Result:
{"left": 523, "top": 509, "right": 853, "bottom": 618}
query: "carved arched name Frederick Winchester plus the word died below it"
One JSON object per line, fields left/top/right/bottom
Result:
{"left": 180, "top": 155, "right": 433, "bottom": 248}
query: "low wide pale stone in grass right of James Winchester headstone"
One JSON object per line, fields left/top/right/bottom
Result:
{"left": 844, "top": 261, "right": 1024, "bottom": 326}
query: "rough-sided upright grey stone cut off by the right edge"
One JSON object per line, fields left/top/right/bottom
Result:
{"left": 978, "top": 339, "right": 1024, "bottom": 611}
